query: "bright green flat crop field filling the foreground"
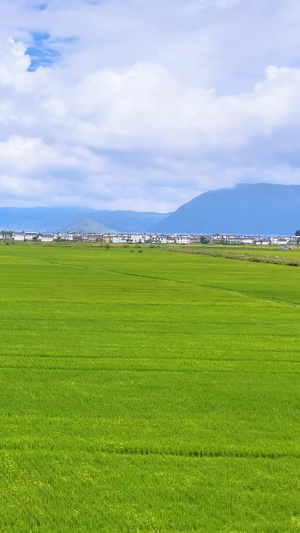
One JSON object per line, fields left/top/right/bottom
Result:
{"left": 0, "top": 245, "right": 300, "bottom": 533}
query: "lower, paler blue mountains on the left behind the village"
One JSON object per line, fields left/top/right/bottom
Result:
{"left": 0, "top": 207, "right": 167, "bottom": 233}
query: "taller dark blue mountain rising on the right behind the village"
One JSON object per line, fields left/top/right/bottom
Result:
{"left": 156, "top": 183, "right": 300, "bottom": 235}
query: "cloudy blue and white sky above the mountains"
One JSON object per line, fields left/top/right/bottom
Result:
{"left": 0, "top": 0, "right": 300, "bottom": 212}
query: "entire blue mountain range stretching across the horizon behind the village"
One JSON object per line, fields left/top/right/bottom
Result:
{"left": 0, "top": 183, "right": 300, "bottom": 235}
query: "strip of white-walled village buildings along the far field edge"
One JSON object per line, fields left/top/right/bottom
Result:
{"left": 0, "top": 230, "right": 299, "bottom": 247}
